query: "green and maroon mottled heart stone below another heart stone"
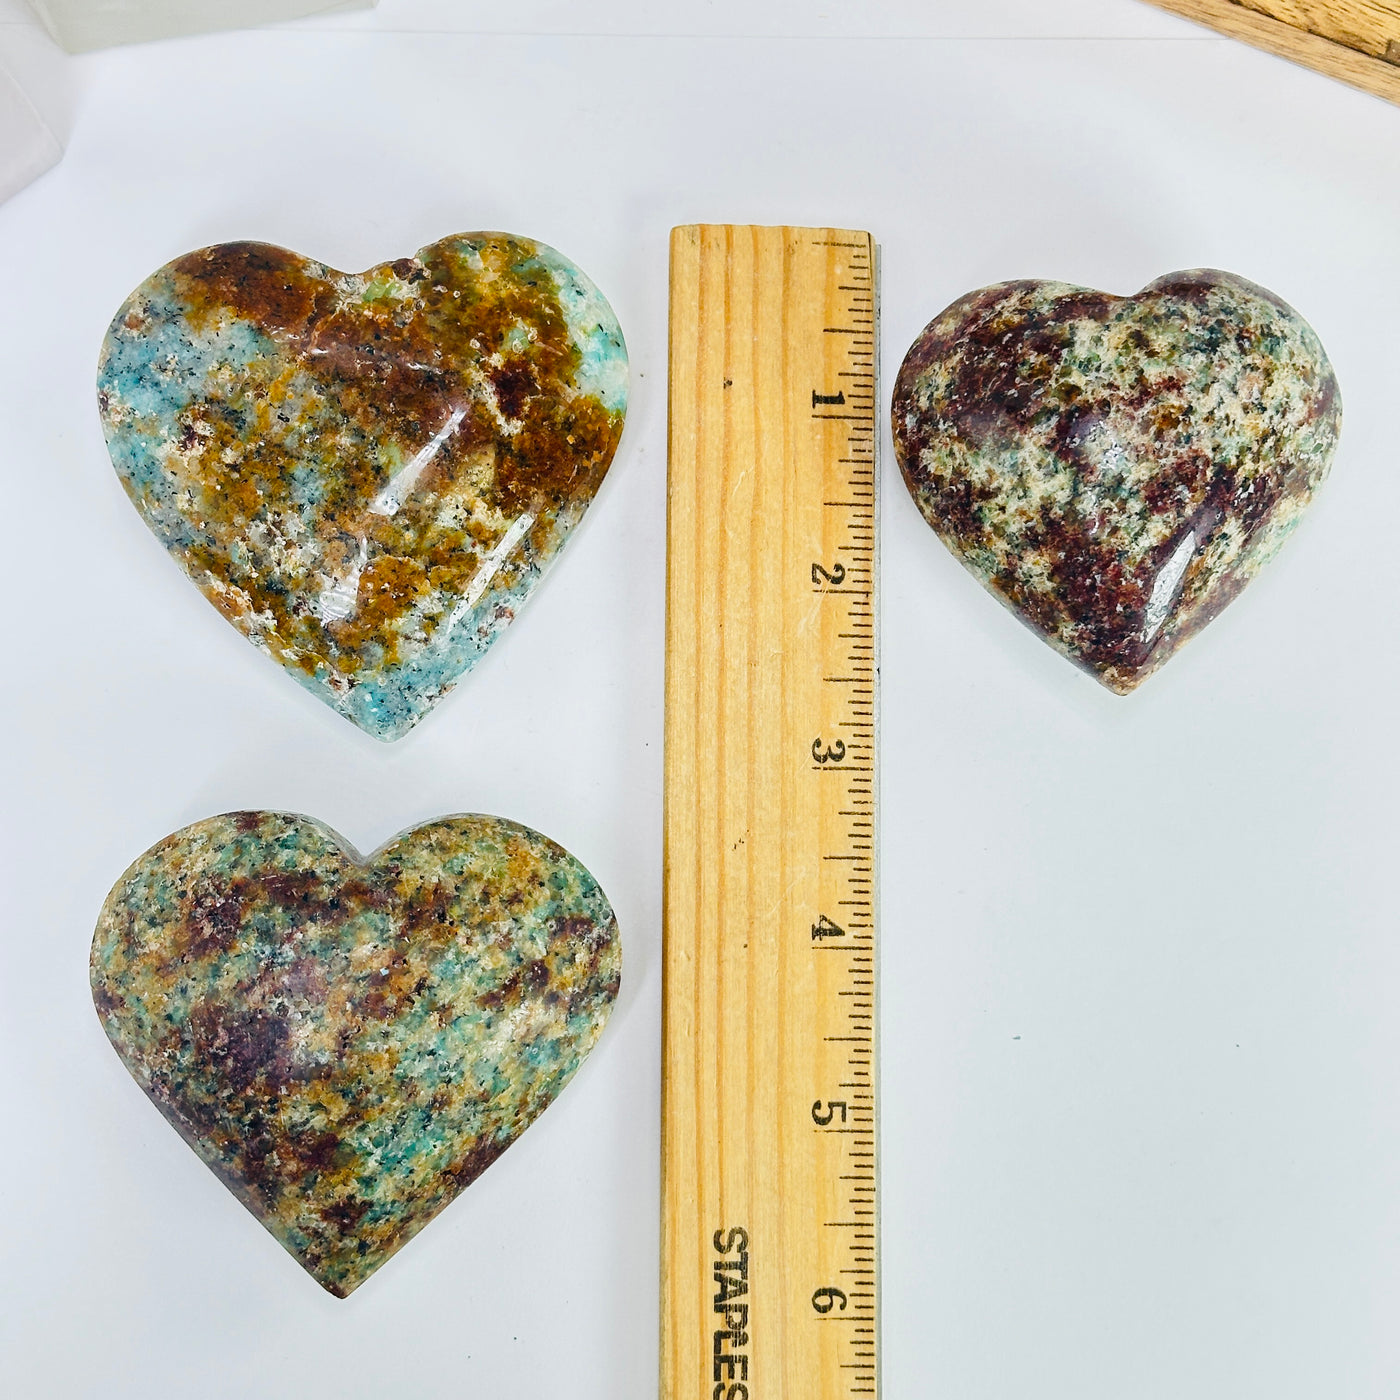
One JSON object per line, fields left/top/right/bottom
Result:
{"left": 91, "top": 812, "right": 620, "bottom": 1298}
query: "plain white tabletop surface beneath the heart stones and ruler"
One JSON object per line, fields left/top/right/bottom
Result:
{"left": 0, "top": 0, "right": 1400, "bottom": 1400}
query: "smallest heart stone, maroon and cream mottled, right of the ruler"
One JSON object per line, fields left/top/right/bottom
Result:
{"left": 892, "top": 272, "right": 1341, "bottom": 694}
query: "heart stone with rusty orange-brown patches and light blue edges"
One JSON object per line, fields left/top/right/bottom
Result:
{"left": 98, "top": 234, "right": 627, "bottom": 739}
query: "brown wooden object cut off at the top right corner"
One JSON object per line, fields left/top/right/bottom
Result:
{"left": 1148, "top": 0, "right": 1400, "bottom": 102}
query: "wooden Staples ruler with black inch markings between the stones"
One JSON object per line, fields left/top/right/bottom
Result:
{"left": 661, "top": 225, "right": 879, "bottom": 1400}
